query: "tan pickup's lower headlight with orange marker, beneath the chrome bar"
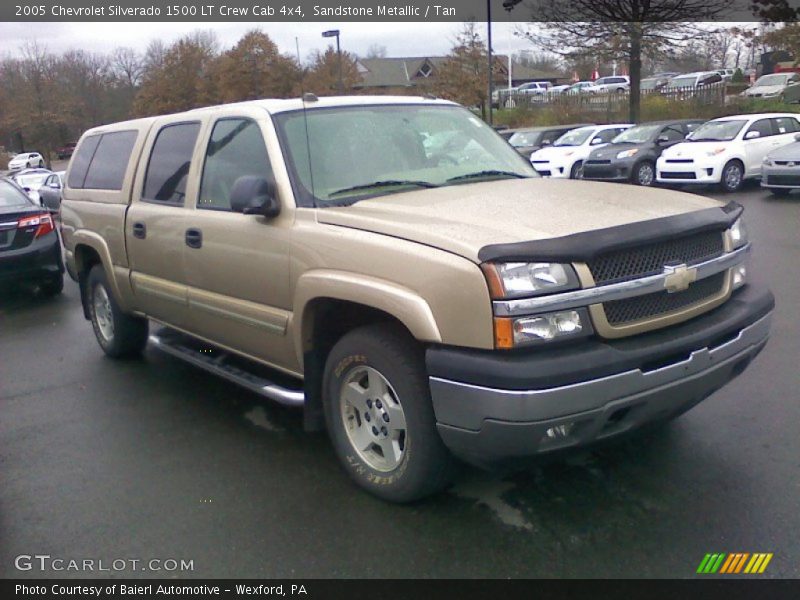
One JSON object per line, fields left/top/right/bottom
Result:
{"left": 494, "top": 308, "right": 592, "bottom": 350}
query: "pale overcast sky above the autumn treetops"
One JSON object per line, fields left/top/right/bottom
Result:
{"left": 0, "top": 22, "right": 530, "bottom": 60}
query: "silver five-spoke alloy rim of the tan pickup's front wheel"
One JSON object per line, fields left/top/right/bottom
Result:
{"left": 339, "top": 366, "right": 406, "bottom": 473}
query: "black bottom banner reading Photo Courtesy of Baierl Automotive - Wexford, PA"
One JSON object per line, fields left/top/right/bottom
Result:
{"left": 0, "top": 578, "right": 800, "bottom": 600}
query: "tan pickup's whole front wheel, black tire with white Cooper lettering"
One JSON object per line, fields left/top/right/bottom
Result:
{"left": 323, "top": 324, "right": 456, "bottom": 502}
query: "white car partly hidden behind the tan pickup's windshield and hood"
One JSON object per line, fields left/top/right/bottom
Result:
{"left": 531, "top": 123, "right": 633, "bottom": 179}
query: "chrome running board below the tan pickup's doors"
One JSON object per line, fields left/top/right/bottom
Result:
{"left": 149, "top": 328, "right": 305, "bottom": 406}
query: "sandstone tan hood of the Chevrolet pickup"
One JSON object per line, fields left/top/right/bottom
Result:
{"left": 317, "top": 178, "right": 723, "bottom": 263}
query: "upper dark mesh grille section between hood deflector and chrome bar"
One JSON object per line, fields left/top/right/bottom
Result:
{"left": 587, "top": 231, "right": 724, "bottom": 285}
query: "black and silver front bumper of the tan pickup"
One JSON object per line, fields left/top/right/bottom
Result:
{"left": 426, "top": 286, "right": 774, "bottom": 465}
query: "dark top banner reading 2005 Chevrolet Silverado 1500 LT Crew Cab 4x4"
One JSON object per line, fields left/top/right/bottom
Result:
{"left": 0, "top": 0, "right": 788, "bottom": 23}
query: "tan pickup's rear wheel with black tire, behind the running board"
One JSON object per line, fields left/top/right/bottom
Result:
{"left": 86, "top": 265, "right": 148, "bottom": 358}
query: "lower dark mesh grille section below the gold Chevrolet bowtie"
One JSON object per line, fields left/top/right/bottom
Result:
{"left": 603, "top": 272, "right": 725, "bottom": 326}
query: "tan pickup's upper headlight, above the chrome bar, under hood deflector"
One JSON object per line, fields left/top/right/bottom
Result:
{"left": 481, "top": 262, "right": 580, "bottom": 300}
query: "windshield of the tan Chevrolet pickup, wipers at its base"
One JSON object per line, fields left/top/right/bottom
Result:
{"left": 274, "top": 105, "right": 537, "bottom": 206}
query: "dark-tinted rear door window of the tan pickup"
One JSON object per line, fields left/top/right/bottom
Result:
{"left": 142, "top": 122, "right": 200, "bottom": 206}
